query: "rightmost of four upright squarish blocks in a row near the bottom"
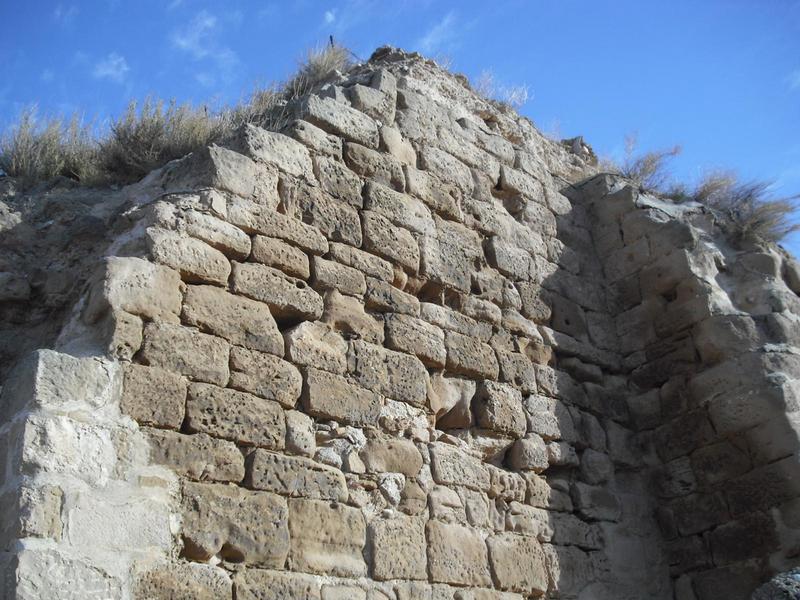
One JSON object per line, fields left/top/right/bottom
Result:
{"left": 486, "top": 533, "right": 547, "bottom": 595}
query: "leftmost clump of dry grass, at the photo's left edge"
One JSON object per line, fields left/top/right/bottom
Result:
{"left": 0, "top": 107, "right": 97, "bottom": 187}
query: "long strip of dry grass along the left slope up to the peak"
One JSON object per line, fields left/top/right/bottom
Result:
{"left": 0, "top": 45, "right": 352, "bottom": 188}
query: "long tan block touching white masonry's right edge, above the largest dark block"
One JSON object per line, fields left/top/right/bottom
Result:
{"left": 147, "top": 429, "right": 244, "bottom": 483}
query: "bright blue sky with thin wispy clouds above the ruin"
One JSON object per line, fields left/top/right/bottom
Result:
{"left": 0, "top": 0, "right": 800, "bottom": 254}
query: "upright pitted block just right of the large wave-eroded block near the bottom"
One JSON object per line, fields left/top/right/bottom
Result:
{"left": 368, "top": 517, "right": 428, "bottom": 581}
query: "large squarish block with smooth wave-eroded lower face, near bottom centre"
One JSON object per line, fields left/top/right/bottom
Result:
{"left": 289, "top": 499, "right": 367, "bottom": 577}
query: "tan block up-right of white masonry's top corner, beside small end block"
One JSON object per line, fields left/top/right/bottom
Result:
{"left": 141, "top": 323, "right": 230, "bottom": 385}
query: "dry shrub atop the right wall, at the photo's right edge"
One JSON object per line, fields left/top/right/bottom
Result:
{"left": 691, "top": 172, "right": 800, "bottom": 242}
